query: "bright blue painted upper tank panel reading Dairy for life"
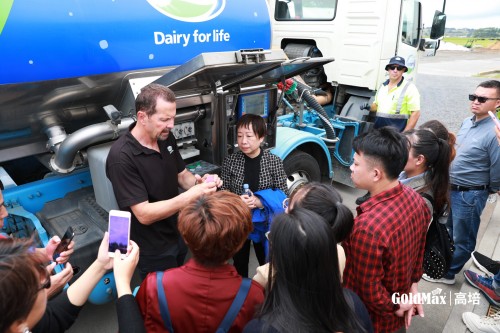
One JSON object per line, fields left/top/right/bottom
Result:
{"left": 0, "top": 0, "right": 271, "bottom": 85}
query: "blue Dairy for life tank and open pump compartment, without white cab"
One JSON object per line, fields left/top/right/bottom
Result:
{"left": 0, "top": 0, "right": 331, "bottom": 303}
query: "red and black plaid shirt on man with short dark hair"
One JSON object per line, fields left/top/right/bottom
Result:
{"left": 344, "top": 184, "right": 431, "bottom": 332}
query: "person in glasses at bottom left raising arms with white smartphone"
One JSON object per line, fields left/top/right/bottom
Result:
{"left": 0, "top": 232, "right": 145, "bottom": 333}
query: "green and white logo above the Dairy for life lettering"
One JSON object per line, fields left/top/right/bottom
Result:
{"left": 148, "top": 0, "right": 226, "bottom": 22}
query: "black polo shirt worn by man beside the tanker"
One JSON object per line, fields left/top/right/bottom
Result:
{"left": 106, "top": 123, "right": 186, "bottom": 255}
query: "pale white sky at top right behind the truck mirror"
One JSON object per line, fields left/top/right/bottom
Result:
{"left": 421, "top": 0, "right": 500, "bottom": 29}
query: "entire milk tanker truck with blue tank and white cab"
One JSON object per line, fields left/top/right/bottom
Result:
{"left": 0, "top": 0, "right": 445, "bottom": 304}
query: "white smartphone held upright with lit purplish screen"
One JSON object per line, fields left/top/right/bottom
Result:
{"left": 108, "top": 210, "right": 131, "bottom": 258}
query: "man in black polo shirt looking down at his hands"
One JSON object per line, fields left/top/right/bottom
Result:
{"left": 106, "top": 84, "right": 222, "bottom": 279}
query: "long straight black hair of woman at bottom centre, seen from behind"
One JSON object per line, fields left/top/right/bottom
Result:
{"left": 258, "top": 208, "right": 359, "bottom": 332}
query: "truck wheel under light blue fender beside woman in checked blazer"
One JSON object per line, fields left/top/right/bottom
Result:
{"left": 283, "top": 151, "right": 321, "bottom": 195}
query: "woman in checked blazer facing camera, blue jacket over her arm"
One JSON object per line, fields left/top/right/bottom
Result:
{"left": 221, "top": 114, "right": 288, "bottom": 277}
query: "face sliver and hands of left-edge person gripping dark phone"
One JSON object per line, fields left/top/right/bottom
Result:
{"left": 0, "top": 180, "right": 75, "bottom": 298}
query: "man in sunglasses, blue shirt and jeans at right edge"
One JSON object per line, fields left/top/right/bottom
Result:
{"left": 424, "top": 80, "right": 500, "bottom": 284}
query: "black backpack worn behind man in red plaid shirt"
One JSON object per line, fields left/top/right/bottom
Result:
{"left": 420, "top": 193, "right": 455, "bottom": 279}
